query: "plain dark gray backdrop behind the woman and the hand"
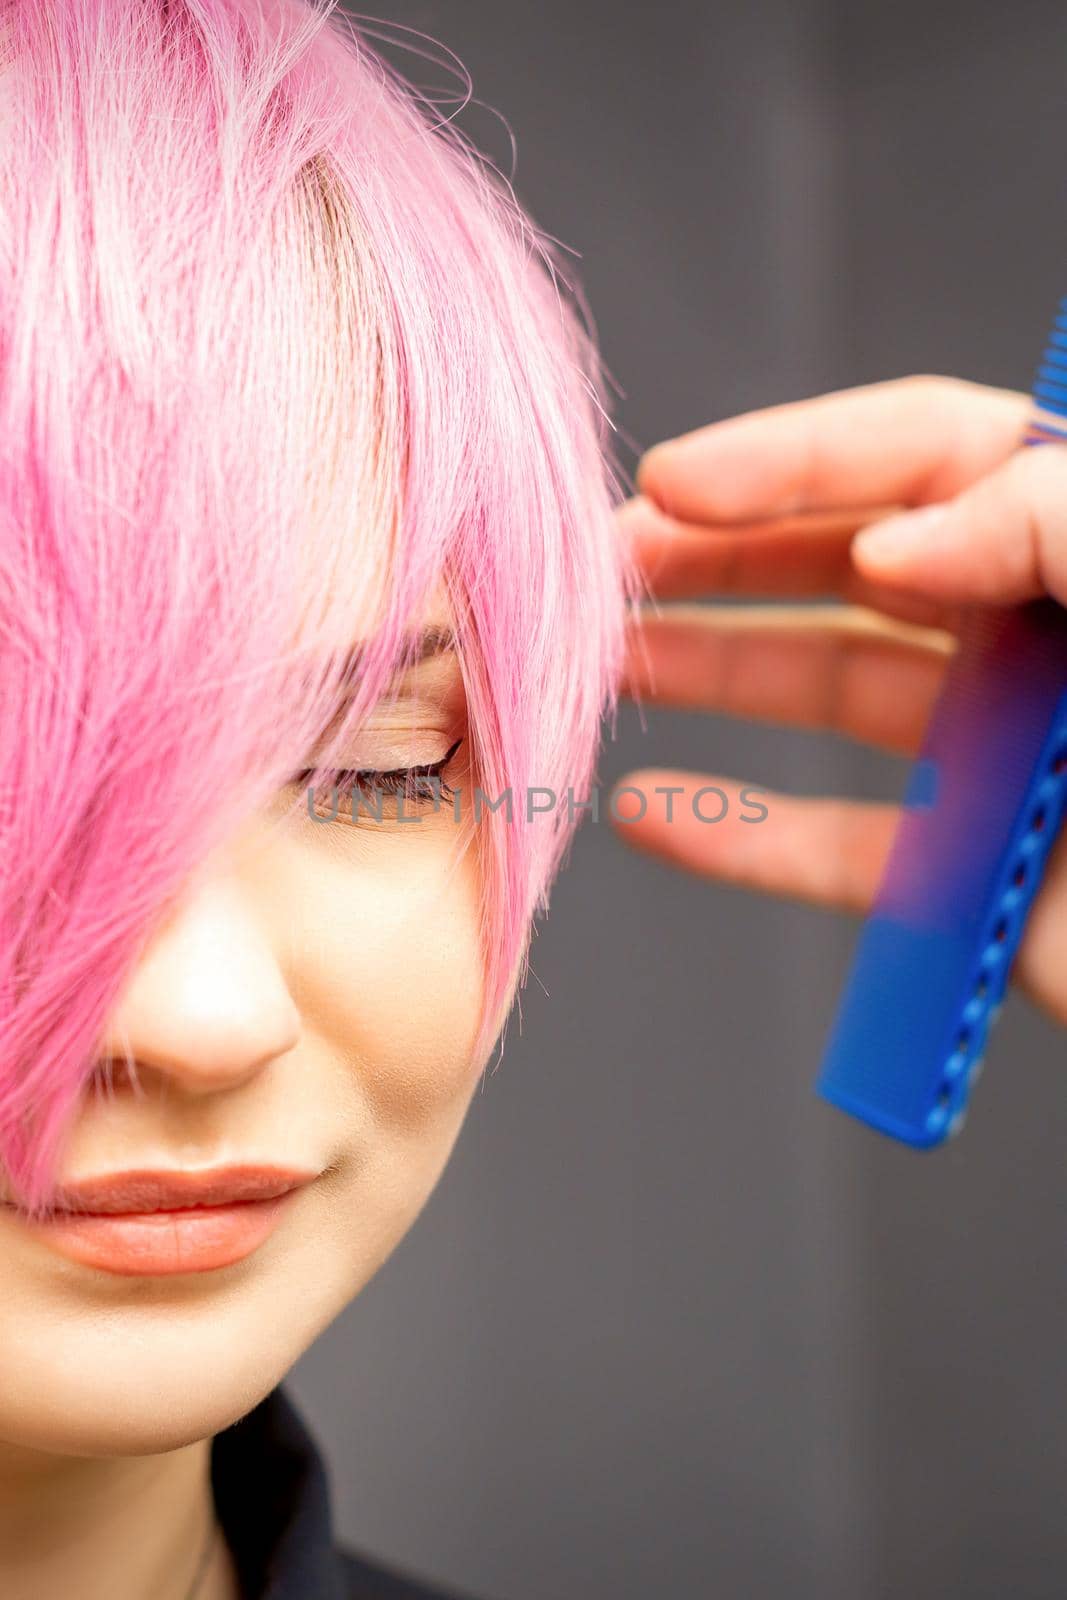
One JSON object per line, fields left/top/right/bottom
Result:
{"left": 291, "top": 0, "right": 1067, "bottom": 1600}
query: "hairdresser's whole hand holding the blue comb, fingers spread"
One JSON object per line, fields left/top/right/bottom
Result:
{"left": 614, "top": 378, "right": 1067, "bottom": 1022}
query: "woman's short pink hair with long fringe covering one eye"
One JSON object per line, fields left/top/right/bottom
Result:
{"left": 0, "top": 0, "right": 635, "bottom": 1206}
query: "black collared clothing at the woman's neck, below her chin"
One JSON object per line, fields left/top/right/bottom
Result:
{"left": 211, "top": 1389, "right": 489, "bottom": 1600}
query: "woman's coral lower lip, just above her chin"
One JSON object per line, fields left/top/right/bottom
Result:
{"left": 9, "top": 1189, "right": 296, "bottom": 1277}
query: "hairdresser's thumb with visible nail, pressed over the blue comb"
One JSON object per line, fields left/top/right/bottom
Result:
{"left": 851, "top": 445, "right": 1067, "bottom": 605}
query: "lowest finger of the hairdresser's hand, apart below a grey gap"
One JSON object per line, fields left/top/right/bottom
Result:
{"left": 611, "top": 768, "right": 901, "bottom": 912}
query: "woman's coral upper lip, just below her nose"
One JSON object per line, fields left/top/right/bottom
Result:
{"left": 9, "top": 1165, "right": 318, "bottom": 1216}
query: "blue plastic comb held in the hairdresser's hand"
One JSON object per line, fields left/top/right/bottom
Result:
{"left": 816, "top": 299, "right": 1067, "bottom": 1149}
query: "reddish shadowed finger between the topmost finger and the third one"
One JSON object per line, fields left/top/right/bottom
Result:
{"left": 616, "top": 496, "right": 957, "bottom": 629}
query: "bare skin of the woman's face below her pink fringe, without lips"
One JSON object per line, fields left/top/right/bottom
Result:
{"left": 0, "top": 602, "right": 511, "bottom": 1454}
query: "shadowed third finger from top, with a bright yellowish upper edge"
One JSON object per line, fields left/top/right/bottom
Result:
{"left": 622, "top": 605, "right": 955, "bottom": 755}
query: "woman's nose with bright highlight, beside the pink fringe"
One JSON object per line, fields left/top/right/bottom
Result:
{"left": 101, "top": 870, "right": 301, "bottom": 1094}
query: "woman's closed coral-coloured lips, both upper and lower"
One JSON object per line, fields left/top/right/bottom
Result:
{"left": 5, "top": 1165, "right": 318, "bottom": 1277}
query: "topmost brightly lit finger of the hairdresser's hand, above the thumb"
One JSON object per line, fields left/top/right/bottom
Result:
{"left": 637, "top": 376, "right": 1029, "bottom": 522}
